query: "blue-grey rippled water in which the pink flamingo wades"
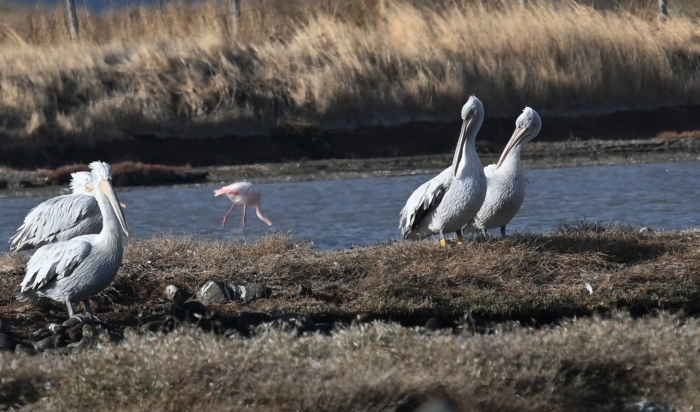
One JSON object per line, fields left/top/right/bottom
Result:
{"left": 0, "top": 162, "right": 700, "bottom": 250}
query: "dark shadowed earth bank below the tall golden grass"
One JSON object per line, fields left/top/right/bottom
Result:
{"left": 0, "top": 106, "right": 700, "bottom": 170}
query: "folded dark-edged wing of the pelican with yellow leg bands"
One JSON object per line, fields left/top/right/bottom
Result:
{"left": 399, "top": 168, "right": 452, "bottom": 238}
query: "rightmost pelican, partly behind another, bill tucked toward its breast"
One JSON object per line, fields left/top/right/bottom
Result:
{"left": 466, "top": 107, "right": 542, "bottom": 237}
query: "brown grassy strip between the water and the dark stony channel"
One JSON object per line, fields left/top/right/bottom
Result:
{"left": 5, "top": 224, "right": 700, "bottom": 322}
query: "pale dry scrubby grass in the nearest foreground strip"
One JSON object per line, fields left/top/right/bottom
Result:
{"left": 0, "top": 314, "right": 700, "bottom": 412}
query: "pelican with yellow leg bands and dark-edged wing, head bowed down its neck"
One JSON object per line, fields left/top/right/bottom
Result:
{"left": 399, "top": 96, "right": 486, "bottom": 246}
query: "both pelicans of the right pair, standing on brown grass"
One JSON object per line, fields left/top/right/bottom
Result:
{"left": 399, "top": 96, "right": 542, "bottom": 246}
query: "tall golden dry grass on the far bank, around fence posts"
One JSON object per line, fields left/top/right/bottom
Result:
{"left": 0, "top": 0, "right": 700, "bottom": 145}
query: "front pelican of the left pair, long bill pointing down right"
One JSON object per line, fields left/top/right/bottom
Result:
{"left": 17, "top": 162, "right": 129, "bottom": 318}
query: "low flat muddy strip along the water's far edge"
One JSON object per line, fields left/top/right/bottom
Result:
{"left": 0, "top": 135, "right": 700, "bottom": 197}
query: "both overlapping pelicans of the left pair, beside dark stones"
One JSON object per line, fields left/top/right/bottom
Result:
{"left": 10, "top": 162, "right": 129, "bottom": 318}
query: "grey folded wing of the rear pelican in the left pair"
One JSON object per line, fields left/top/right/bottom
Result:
{"left": 10, "top": 194, "right": 102, "bottom": 251}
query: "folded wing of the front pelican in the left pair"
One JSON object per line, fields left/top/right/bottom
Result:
{"left": 20, "top": 235, "right": 95, "bottom": 292}
